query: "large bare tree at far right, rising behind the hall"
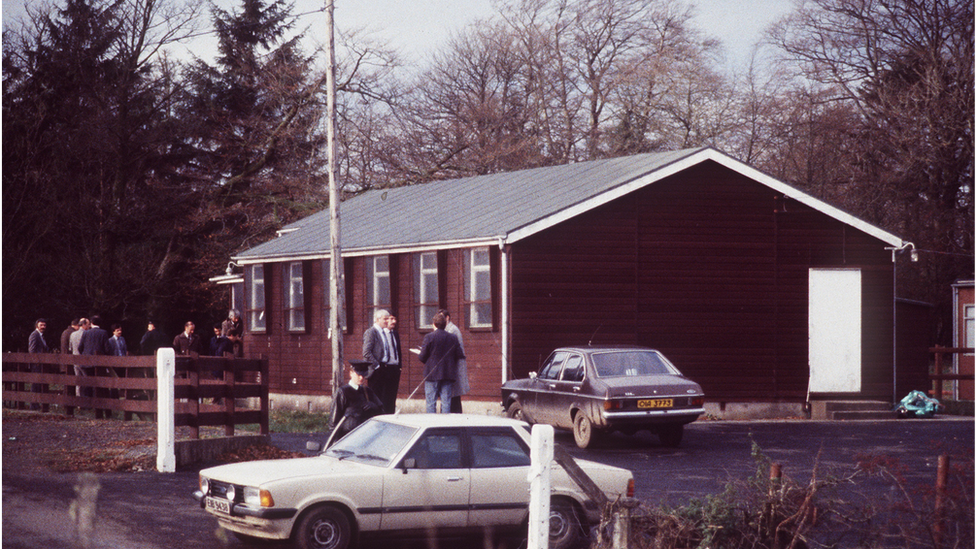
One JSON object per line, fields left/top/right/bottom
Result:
{"left": 770, "top": 0, "right": 976, "bottom": 337}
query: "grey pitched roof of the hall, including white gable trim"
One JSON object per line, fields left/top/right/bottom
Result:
{"left": 233, "top": 148, "right": 902, "bottom": 264}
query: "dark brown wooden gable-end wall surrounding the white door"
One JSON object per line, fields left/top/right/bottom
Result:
{"left": 512, "top": 163, "right": 891, "bottom": 401}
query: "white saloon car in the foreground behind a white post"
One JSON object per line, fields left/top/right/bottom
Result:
{"left": 194, "top": 414, "right": 634, "bottom": 549}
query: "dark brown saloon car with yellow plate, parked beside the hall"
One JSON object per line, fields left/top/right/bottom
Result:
{"left": 502, "top": 347, "right": 705, "bottom": 448}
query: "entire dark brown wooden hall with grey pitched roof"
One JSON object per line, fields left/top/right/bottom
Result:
{"left": 222, "top": 148, "right": 926, "bottom": 413}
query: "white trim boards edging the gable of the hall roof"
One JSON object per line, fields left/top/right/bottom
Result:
{"left": 505, "top": 148, "right": 904, "bottom": 247}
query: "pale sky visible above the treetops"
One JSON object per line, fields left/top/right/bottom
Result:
{"left": 0, "top": 0, "right": 793, "bottom": 67}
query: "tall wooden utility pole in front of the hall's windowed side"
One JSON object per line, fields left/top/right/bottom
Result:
{"left": 325, "top": 0, "right": 346, "bottom": 393}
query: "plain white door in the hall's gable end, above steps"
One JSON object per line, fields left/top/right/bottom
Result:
{"left": 809, "top": 269, "right": 861, "bottom": 393}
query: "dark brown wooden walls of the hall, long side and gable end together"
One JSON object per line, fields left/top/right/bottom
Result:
{"left": 245, "top": 158, "right": 892, "bottom": 401}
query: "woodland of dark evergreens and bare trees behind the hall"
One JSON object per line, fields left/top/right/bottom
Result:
{"left": 0, "top": 0, "right": 976, "bottom": 351}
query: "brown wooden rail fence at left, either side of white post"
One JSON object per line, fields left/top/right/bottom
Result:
{"left": 0, "top": 353, "right": 269, "bottom": 438}
